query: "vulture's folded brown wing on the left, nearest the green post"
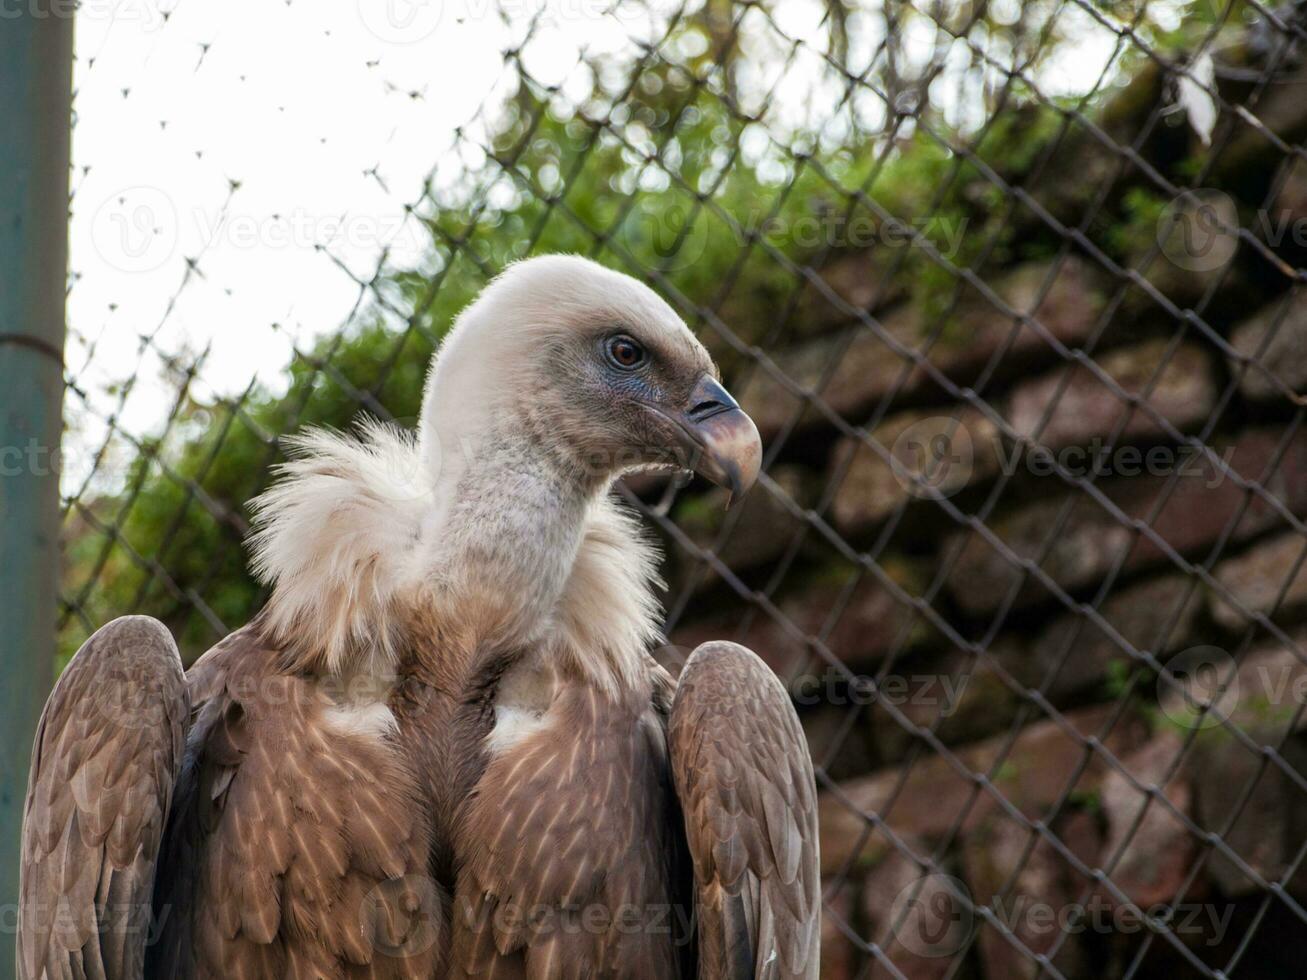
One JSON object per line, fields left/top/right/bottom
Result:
{"left": 18, "top": 615, "right": 190, "bottom": 980}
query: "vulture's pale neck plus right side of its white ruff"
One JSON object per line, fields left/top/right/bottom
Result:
{"left": 421, "top": 416, "right": 661, "bottom": 698}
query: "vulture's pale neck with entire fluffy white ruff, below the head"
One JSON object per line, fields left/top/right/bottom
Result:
{"left": 252, "top": 391, "right": 660, "bottom": 695}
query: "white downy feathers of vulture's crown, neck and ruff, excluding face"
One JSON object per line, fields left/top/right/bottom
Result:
{"left": 251, "top": 256, "right": 684, "bottom": 689}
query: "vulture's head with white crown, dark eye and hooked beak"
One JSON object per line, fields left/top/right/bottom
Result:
{"left": 420, "top": 255, "right": 762, "bottom": 497}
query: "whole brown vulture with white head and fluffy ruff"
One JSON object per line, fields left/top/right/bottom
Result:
{"left": 18, "top": 255, "right": 821, "bottom": 980}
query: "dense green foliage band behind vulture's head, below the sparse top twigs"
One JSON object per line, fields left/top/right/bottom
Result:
{"left": 60, "top": 25, "right": 1103, "bottom": 657}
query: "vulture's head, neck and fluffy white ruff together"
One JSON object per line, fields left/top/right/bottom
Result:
{"left": 254, "top": 255, "right": 762, "bottom": 674}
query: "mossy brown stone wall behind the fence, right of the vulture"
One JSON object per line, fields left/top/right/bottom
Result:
{"left": 651, "top": 40, "right": 1307, "bottom": 980}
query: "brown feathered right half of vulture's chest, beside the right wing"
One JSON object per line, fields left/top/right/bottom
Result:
{"left": 451, "top": 685, "right": 687, "bottom": 980}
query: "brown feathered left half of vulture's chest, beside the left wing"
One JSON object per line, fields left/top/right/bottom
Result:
{"left": 146, "top": 629, "right": 446, "bottom": 980}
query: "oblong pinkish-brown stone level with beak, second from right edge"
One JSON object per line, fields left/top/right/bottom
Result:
{"left": 1008, "top": 340, "right": 1217, "bottom": 448}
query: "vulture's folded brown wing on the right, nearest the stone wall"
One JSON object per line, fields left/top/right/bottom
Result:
{"left": 668, "top": 643, "right": 821, "bottom": 980}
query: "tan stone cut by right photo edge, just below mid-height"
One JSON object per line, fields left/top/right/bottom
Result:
{"left": 1212, "top": 532, "right": 1307, "bottom": 630}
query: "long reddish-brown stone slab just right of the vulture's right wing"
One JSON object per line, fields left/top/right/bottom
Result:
{"left": 818, "top": 704, "right": 1145, "bottom": 874}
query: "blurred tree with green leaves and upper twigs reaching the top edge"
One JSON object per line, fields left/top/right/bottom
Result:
{"left": 61, "top": 0, "right": 1218, "bottom": 656}
